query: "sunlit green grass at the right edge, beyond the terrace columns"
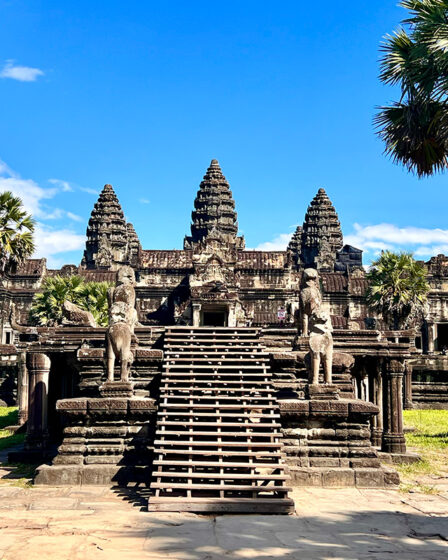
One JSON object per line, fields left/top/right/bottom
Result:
{"left": 397, "top": 410, "right": 448, "bottom": 494}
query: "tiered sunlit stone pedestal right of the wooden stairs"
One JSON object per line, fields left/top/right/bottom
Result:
{"left": 279, "top": 399, "right": 399, "bottom": 488}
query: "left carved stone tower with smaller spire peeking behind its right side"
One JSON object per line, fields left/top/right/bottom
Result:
{"left": 82, "top": 185, "right": 139, "bottom": 270}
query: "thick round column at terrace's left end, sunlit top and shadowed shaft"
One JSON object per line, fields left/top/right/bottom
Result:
{"left": 25, "top": 354, "right": 51, "bottom": 450}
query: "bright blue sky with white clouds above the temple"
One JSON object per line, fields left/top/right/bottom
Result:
{"left": 0, "top": 0, "right": 448, "bottom": 266}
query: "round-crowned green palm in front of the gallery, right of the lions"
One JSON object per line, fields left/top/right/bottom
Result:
{"left": 367, "top": 251, "right": 429, "bottom": 330}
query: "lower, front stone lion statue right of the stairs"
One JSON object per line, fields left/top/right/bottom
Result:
{"left": 309, "top": 310, "right": 333, "bottom": 385}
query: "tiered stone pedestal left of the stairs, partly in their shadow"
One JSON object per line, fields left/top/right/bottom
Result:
{"left": 35, "top": 397, "right": 156, "bottom": 486}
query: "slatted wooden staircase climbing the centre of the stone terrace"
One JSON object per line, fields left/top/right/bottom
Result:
{"left": 148, "top": 327, "right": 294, "bottom": 513}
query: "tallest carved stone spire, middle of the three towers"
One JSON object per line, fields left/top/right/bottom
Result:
{"left": 184, "top": 159, "right": 242, "bottom": 248}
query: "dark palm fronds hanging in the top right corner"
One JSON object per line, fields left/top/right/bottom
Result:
{"left": 374, "top": 0, "right": 448, "bottom": 177}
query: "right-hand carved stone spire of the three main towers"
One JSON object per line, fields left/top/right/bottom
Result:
{"left": 301, "top": 189, "right": 343, "bottom": 270}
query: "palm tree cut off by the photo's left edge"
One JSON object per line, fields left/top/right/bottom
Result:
{"left": 0, "top": 191, "right": 34, "bottom": 275}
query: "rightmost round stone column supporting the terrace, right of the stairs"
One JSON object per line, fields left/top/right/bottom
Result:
{"left": 381, "top": 360, "right": 406, "bottom": 453}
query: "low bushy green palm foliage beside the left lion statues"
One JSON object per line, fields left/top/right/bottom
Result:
{"left": 30, "top": 276, "right": 111, "bottom": 326}
